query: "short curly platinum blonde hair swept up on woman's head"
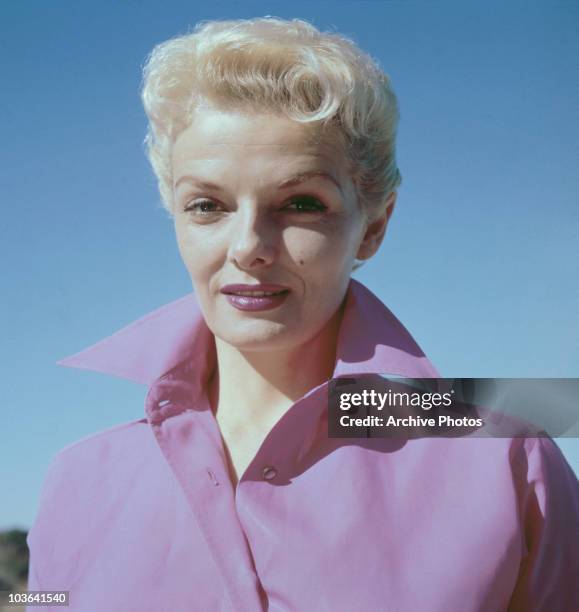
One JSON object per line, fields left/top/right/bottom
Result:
{"left": 142, "top": 16, "right": 401, "bottom": 222}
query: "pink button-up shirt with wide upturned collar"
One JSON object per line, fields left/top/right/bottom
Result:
{"left": 28, "top": 280, "right": 579, "bottom": 612}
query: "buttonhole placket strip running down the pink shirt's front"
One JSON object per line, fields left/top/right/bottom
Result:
{"left": 145, "top": 376, "right": 265, "bottom": 612}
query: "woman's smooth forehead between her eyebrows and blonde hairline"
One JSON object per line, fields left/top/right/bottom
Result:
{"left": 172, "top": 108, "right": 347, "bottom": 174}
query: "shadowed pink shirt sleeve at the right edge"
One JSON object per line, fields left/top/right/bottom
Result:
{"left": 509, "top": 437, "right": 579, "bottom": 612}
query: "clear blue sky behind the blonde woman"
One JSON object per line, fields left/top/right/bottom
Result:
{"left": 0, "top": 0, "right": 579, "bottom": 528}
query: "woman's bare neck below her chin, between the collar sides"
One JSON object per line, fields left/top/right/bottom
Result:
{"left": 209, "top": 300, "right": 342, "bottom": 428}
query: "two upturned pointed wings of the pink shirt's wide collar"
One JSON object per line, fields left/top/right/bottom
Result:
{"left": 57, "top": 279, "right": 439, "bottom": 386}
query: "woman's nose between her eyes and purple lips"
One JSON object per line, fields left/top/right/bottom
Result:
{"left": 229, "top": 206, "right": 276, "bottom": 270}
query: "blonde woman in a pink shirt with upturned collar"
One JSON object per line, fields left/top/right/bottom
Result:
{"left": 29, "top": 18, "right": 579, "bottom": 612}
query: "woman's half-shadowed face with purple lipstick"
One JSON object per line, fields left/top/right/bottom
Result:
{"left": 172, "top": 108, "right": 388, "bottom": 350}
